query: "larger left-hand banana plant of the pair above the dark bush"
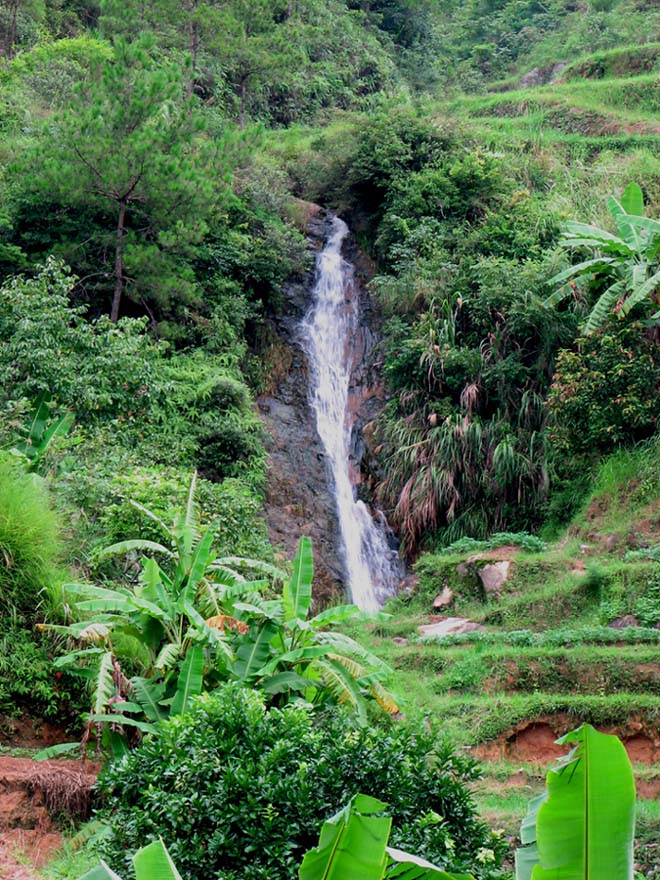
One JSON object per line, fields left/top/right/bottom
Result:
{"left": 43, "top": 476, "right": 265, "bottom": 756}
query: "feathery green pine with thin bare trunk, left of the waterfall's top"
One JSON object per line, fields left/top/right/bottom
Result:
{"left": 40, "top": 36, "right": 220, "bottom": 321}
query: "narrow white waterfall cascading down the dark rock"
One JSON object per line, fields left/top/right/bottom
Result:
{"left": 302, "top": 217, "right": 402, "bottom": 611}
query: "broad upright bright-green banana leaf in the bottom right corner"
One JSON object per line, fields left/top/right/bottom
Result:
{"left": 516, "top": 724, "right": 635, "bottom": 880}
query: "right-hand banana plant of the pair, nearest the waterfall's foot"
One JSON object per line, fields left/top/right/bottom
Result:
{"left": 232, "top": 537, "right": 399, "bottom": 720}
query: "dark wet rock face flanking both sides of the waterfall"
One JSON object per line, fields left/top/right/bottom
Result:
{"left": 257, "top": 208, "right": 402, "bottom": 604}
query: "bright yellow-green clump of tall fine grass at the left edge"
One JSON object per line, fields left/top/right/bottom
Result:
{"left": 0, "top": 454, "right": 62, "bottom": 623}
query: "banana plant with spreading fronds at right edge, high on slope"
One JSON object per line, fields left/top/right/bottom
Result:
{"left": 545, "top": 183, "right": 660, "bottom": 333}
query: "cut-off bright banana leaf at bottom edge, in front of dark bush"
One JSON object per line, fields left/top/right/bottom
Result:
{"left": 298, "top": 794, "right": 473, "bottom": 880}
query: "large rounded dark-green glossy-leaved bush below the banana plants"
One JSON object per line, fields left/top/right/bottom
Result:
{"left": 99, "top": 686, "right": 501, "bottom": 880}
